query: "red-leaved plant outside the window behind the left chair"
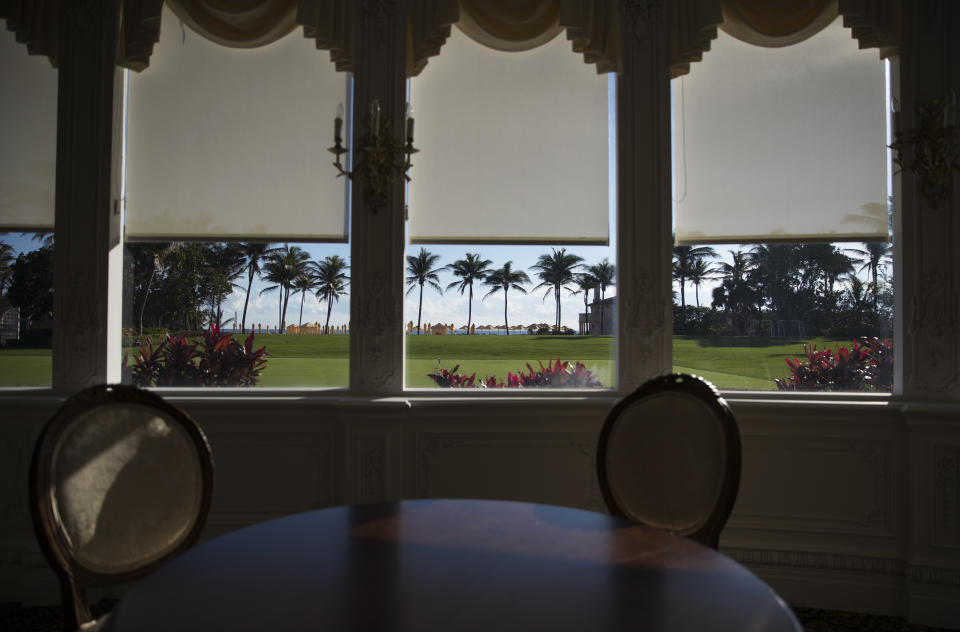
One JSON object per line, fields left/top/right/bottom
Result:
{"left": 123, "top": 327, "right": 269, "bottom": 386}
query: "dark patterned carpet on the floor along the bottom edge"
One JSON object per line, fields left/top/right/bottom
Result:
{"left": 0, "top": 600, "right": 951, "bottom": 632}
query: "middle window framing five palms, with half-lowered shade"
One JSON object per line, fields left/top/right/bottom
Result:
{"left": 404, "top": 28, "right": 617, "bottom": 388}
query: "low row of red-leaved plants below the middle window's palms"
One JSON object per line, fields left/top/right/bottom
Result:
{"left": 427, "top": 358, "right": 603, "bottom": 388}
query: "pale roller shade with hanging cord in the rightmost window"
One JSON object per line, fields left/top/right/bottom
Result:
{"left": 673, "top": 19, "right": 887, "bottom": 244}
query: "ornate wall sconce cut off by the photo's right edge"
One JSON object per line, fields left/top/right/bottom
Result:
{"left": 890, "top": 96, "right": 960, "bottom": 206}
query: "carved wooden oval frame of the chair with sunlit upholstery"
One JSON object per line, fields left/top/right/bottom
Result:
{"left": 29, "top": 384, "right": 214, "bottom": 630}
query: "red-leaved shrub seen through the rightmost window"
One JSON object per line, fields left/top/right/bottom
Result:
{"left": 774, "top": 338, "right": 893, "bottom": 392}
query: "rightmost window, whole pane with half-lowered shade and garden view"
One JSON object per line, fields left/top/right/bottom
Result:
{"left": 673, "top": 18, "right": 893, "bottom": 391}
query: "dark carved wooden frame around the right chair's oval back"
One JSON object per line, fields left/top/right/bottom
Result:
{"left": 597, "top": 373, "right": 742, "bottom": 549}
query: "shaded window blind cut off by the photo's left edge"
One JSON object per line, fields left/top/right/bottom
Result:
{"left": 0, "top": 29, "right": 57, "bottom": 231}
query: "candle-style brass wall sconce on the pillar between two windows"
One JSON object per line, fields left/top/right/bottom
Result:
{"left": 328, "top": 99, "right": 419, "bottom": 211}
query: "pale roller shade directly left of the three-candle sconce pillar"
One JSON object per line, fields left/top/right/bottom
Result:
{"left": 126, "top": 10, "right": 349, "bottom": 241}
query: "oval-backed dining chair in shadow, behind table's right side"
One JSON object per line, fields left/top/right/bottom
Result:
{"left": 597, "top": 374, "right": 740, "bottom": 549}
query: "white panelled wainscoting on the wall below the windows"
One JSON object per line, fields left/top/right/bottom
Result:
{"left": 0, "top": 391, "right": 960, "bottom": 628}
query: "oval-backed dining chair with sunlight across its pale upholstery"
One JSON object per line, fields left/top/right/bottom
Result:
{"left": 29, "top": 384, "right": 213, "bottom": 631}
